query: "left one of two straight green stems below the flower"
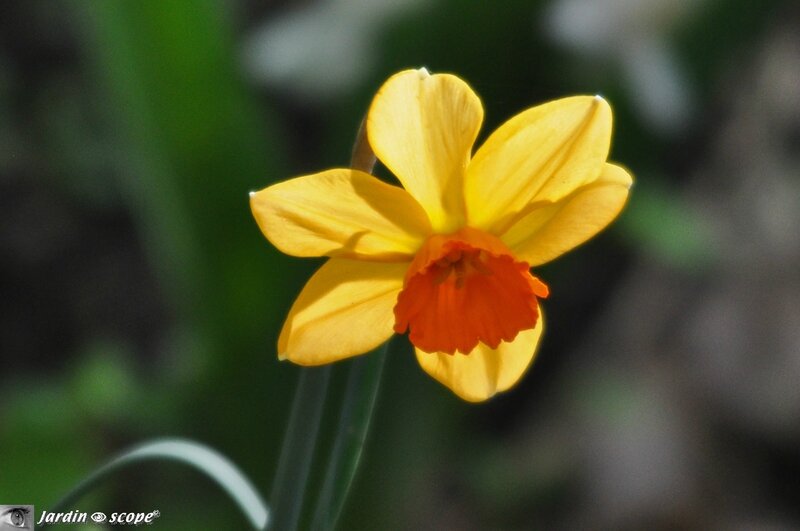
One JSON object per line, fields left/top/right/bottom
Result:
{"left": 270, "top": 365, "right": 331, "bottom": 531}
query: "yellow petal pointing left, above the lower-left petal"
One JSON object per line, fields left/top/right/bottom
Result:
{"left": 250, "top": 169, "right": 430, "bottom": 260}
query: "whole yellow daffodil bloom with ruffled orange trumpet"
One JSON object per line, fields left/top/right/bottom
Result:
{"left": 251, "top": 69, "right": 632, "bottom": 401}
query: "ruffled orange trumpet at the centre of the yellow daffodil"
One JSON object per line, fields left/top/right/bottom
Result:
{"left": 394, "top": 227, "right": 548, "bottom": 354}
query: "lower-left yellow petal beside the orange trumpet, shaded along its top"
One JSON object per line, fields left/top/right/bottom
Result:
{"left": 278, "top": 258, "right": 408, "bottom": 365}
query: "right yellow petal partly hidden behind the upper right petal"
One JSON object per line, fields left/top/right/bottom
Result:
{"left": 500, "top": 164, "right": 633, "bottom": 266}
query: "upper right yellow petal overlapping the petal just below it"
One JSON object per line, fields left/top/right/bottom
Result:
{"left": 464, "top": 96, "right": 611, "bottom": 236}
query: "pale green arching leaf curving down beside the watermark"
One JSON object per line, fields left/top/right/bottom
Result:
{"left": 36, "top": 439, "right": 269, "bottom": 530}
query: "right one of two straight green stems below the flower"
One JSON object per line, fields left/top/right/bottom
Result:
{"left": 311, "top": 341, "right": 389, "bottom": 530}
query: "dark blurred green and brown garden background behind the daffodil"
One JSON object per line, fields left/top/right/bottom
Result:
{"left": 0, "top": 0, "right": 800, "bottom": 530}
